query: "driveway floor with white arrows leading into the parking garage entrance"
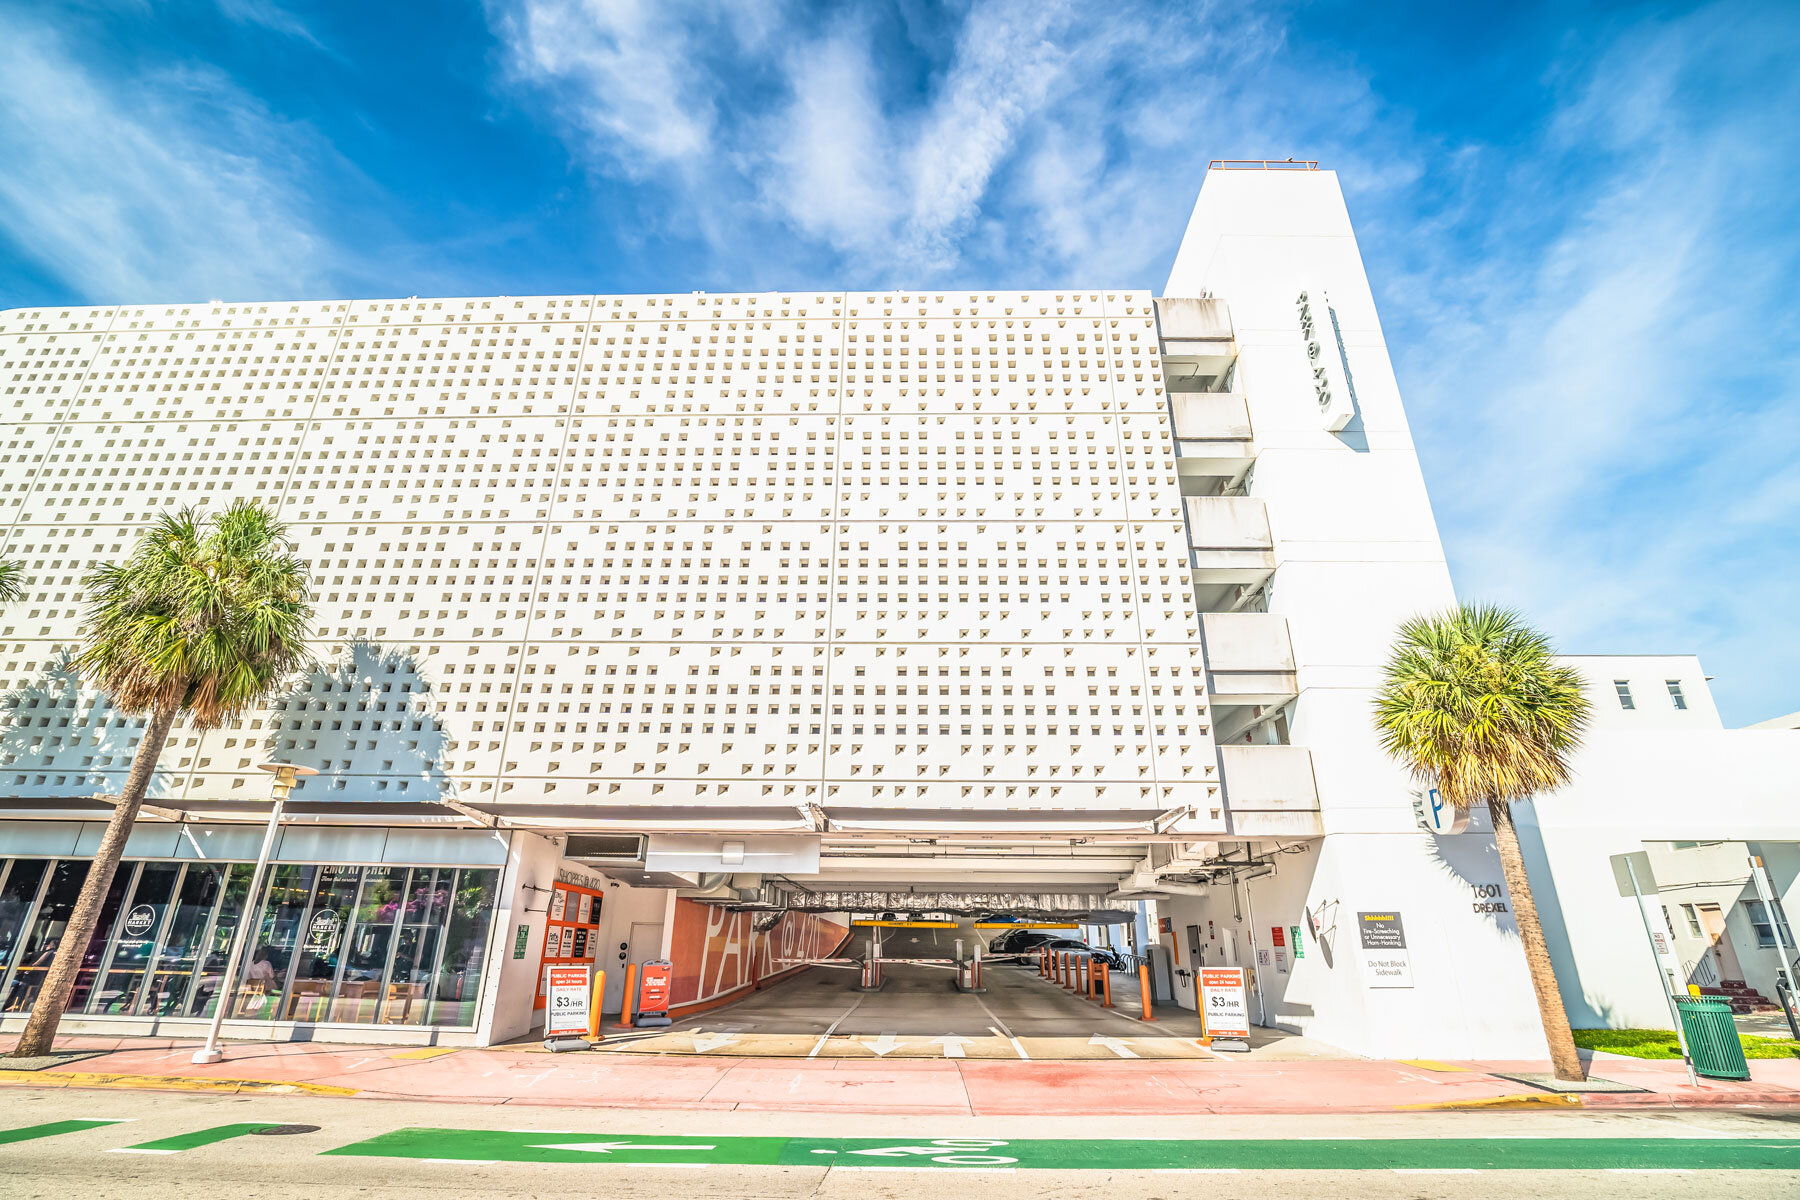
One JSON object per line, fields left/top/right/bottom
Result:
{"left": 599, "top": 919, "right": 1213, "bottom": 1060}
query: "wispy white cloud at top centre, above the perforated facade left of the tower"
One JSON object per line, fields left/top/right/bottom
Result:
{"left": 490, "top": 0, "right": 1346, "bottom": 284}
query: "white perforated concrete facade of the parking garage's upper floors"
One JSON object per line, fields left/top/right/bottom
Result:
{"left": 0, "top": 291, "right": 1224, "bottom": 831}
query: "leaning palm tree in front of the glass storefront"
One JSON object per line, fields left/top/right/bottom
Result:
{"left": 13, "top": 500, "right": 311, "bottom": 1058}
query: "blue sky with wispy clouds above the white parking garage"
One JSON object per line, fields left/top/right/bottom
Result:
{"left": 0, "top": 0, "right": 1800, "bottom": 723}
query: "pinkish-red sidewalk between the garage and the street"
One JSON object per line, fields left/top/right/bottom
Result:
{"left": 0, "top": 1036, "right": 1800, "bottom": 1115}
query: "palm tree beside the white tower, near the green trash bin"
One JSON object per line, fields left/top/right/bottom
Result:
{"left": 1375, "top": 604, "right": 1588, "bottom": 1081}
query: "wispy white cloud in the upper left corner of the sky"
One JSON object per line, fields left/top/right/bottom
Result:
{"left": 0, "top": 20, "right": 335, "bottom": 300}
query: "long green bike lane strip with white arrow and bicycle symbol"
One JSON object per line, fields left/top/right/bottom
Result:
{"left": 324, "top": 1128, "right": 1800, "bottom": 1171}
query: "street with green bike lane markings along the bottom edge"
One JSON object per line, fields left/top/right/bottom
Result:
{"left": 0, "top": 1088, "right": 1800, "bottom": 1200}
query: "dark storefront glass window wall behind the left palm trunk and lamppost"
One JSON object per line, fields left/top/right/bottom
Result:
{"left": 0, "top": 858, "right": 499, "bottom": 1027}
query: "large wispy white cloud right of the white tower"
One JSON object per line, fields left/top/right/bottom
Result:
{"left": 1395, "top": 9, "right": 1800, "bottom": 721}
